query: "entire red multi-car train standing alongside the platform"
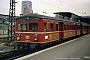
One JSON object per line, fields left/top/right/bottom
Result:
{"left": 15, "top": 14, "right": 90, "bottom": 49}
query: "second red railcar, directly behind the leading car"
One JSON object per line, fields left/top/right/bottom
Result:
{"left": 60, "top": 20, "right": 76, "bottom": 39}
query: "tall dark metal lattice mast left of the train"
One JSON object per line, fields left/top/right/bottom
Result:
{"left": 7, "top": 0, "right": 16, "bottom": 45}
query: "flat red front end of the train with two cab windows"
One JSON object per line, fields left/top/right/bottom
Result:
{"left": 15, "top": 20, "right": 45, "bottom": 44}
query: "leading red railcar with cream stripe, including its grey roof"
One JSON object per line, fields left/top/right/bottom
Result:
{"left": 15, "top": 14, "right": 60, "bottom": 44}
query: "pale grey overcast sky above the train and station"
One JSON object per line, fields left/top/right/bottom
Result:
{"left": 0, "top": 0, "right": 90, "bottom": 16}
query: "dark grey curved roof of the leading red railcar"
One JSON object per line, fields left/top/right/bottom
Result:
{"left": 16, "top": 14, "right": 60, "bottom": 20}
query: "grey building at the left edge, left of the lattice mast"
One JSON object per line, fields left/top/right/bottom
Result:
{"left": 0, "top": 14, "right": 18, "bottom": 36}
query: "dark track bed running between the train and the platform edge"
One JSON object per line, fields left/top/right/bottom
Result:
{"left": 0, "top": 34, "right": 83, "bottom": 60}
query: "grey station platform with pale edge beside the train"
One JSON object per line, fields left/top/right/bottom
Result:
{"left": 15, "top": 34, "right": 90, "bottom": 60}
